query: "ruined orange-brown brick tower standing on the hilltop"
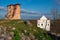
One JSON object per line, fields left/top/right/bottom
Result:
{"left": 6, "top": 4, "right": 21, "bottom": 20}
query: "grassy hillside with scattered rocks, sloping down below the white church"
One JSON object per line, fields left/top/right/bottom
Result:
{"left": 0, "top": 20, "right": 52, "bottom": 40}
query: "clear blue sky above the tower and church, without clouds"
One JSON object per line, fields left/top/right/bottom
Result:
{"left": 0, "top": 0, "right": 60, "bottom": 18}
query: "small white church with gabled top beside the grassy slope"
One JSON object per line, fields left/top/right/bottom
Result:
{"left": 37, "top": 16, "right": 50, "bottom": 31}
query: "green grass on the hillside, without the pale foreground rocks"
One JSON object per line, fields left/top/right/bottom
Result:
{"left": 0, "top": 20, "right": 52, "bottom": 40}
